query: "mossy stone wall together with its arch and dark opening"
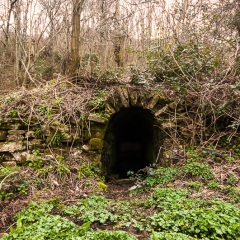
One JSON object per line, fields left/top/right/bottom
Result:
{"left": 0, "top": 86, "right": 176, "bottom": 178}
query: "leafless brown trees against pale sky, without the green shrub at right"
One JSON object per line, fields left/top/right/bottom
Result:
{"left": 0, "top": 0, "right": 240, "bottom": 89}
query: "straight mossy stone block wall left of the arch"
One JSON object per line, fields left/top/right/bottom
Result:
{"left": 0, "top": 114, "right": 106, "bottom": 167}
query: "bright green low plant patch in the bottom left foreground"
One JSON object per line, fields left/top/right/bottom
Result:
{"left": 2, "top": 199, "right": 137, "bottom": 240}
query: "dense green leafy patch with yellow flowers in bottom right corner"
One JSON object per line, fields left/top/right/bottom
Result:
{"left": 148, "top": 189, "right": 240, "bottom": 239}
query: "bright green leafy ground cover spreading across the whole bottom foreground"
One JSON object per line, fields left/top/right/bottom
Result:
{"left": 3, "top": 184, "right": 240, "bottom": 240}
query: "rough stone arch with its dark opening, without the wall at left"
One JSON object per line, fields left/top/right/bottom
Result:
{"left": 89, "top": 85, "right": 175, "bottom": 179}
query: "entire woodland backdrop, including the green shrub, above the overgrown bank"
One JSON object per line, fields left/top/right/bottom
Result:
{"left": 0, "top": 0, "right": 240, "bottom": 90}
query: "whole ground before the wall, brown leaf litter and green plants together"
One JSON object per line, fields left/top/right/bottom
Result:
{"left": 1, "top": 149, "right": 240, "bottom": 240}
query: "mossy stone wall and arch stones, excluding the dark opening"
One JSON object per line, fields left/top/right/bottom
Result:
{"left": 0, "top": 86, "right": 179, "bottom": 173}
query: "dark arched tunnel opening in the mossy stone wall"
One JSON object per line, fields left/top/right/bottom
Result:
{"left": 102, "top": 107, "right": 160, "bottom": 178}
